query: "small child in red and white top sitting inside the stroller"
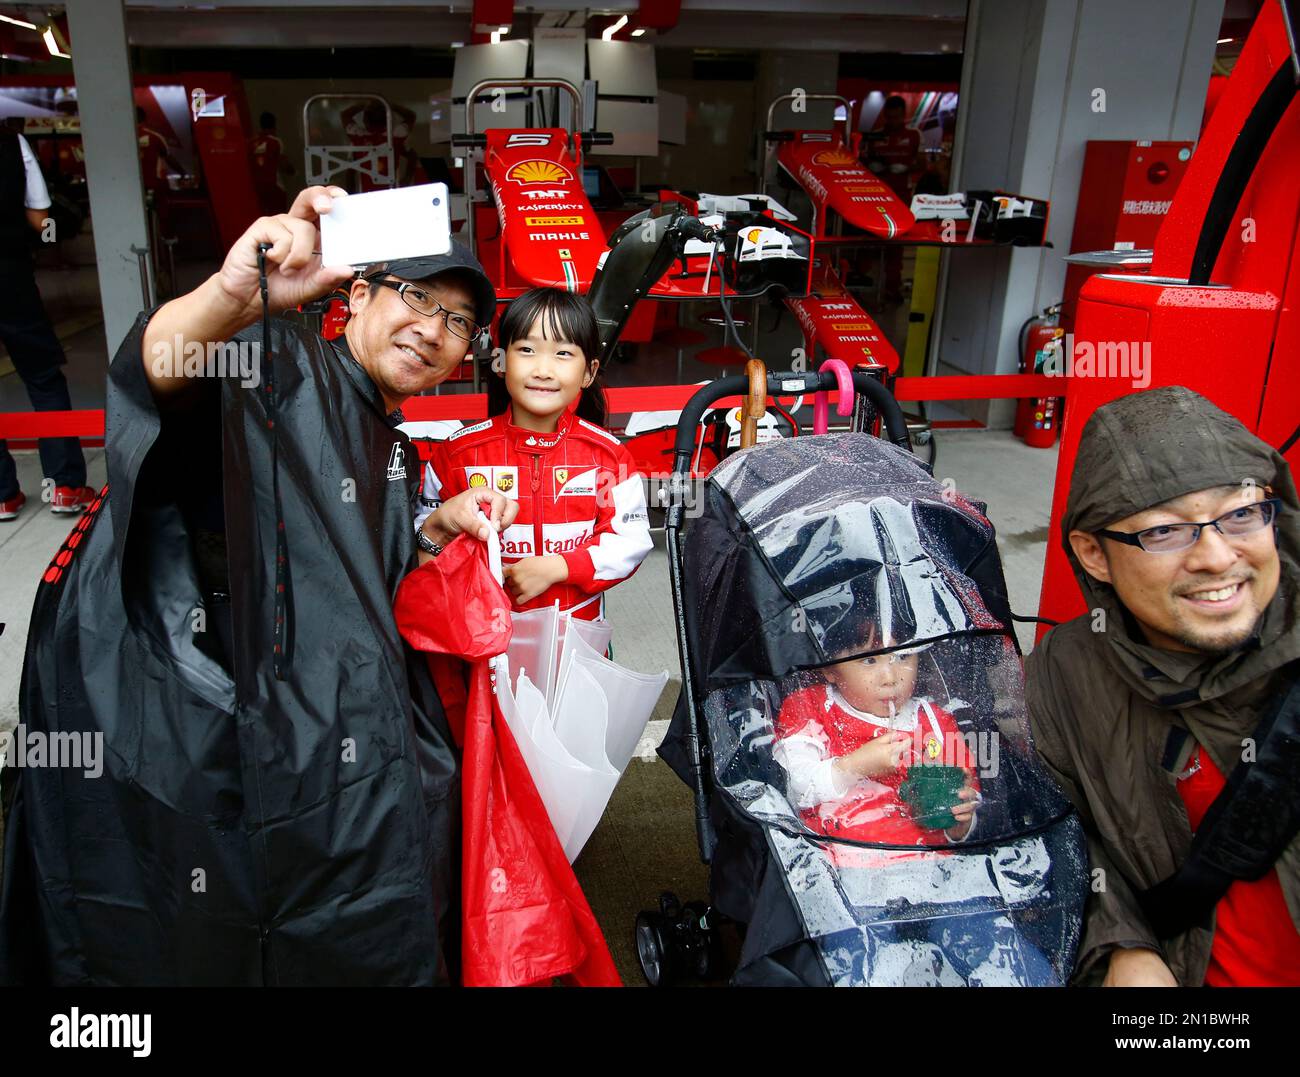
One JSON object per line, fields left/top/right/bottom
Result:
{"left": 772, "top": 618, "right": 1061, "bottom": 987}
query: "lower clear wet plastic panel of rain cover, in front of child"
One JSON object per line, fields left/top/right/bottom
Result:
{"left": 705, "top": 635, "right": 1087, "bottom": 986}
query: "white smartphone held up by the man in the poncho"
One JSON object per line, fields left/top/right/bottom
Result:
{"left": 320, "top": 183, "right": 451, "bottom": 267}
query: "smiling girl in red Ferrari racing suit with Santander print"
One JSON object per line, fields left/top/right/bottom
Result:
{"left": 416, "top": 287, "right": 653, "bottom": 620}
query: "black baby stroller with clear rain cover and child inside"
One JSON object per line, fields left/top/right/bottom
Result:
{"left": 650, "top": 373, "right": 1087, "bottom": 986}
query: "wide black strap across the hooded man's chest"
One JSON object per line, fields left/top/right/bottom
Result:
{"left": 1138, "top": 663, "right": 1300, "bottom": 939}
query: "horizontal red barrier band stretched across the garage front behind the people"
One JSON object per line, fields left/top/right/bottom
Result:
{"left": 0, "top": 375, "right": 1066, "bottom": 438}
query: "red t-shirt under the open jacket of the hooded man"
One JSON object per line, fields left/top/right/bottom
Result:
{"left": 1178, "top": 744, "right": 1300, "bottom": 987}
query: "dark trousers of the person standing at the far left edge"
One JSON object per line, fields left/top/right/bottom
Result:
{"left": 0, "top": 256, "right": 86, "bottom": 501}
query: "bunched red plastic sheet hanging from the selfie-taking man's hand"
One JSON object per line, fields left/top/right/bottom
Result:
{"left": 394, "top": 536, "right": 620, "bottom": 987}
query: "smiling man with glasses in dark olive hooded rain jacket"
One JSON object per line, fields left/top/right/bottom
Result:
{"left": 1026, "top": 386, "right": 1300, "bottom": 986}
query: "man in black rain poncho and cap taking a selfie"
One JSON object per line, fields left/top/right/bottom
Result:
{"left": 0, "top": 187, "right": 515, "bottom": 985}
